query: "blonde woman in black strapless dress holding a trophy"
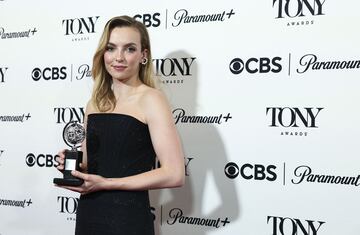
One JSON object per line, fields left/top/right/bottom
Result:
{"left": 58, "top": 16, "right": 185, "bottom": 235}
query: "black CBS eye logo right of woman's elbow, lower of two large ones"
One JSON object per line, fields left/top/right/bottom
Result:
{"left": 224, "top": 162, "right": 277, "bottom": 181}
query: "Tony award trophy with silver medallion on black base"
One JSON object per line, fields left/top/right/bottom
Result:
{"left": 54, "top": 121, "right": 85, "bottom": 186}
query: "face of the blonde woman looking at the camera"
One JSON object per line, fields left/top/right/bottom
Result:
{"left": 104, "top": 27, "right": 146, "bottom": 82}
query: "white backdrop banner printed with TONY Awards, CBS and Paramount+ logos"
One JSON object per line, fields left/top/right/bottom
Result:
{"left": 0, "top": 0, "right": 360, "bottom": 235}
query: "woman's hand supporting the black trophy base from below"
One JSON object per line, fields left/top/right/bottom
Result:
{"left": 58, "top": 171, "right": 107, "bottom": 195}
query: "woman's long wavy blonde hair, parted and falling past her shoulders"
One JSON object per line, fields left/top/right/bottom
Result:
{"left": 91, "top": 16, "right": 155, "bottom": 112}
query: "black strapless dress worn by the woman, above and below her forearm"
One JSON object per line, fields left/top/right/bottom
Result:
{"left": 75, "top": 113, "right": 155, "bottom": 235}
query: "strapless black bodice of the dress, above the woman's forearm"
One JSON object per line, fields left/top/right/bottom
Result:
{"left": 86, "top": 113, "right": 155, "bottom": 177}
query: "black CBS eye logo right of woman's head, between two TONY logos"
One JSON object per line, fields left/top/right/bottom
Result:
{"left": 229, "top": 56, "right": 282, "bottom": 75}
